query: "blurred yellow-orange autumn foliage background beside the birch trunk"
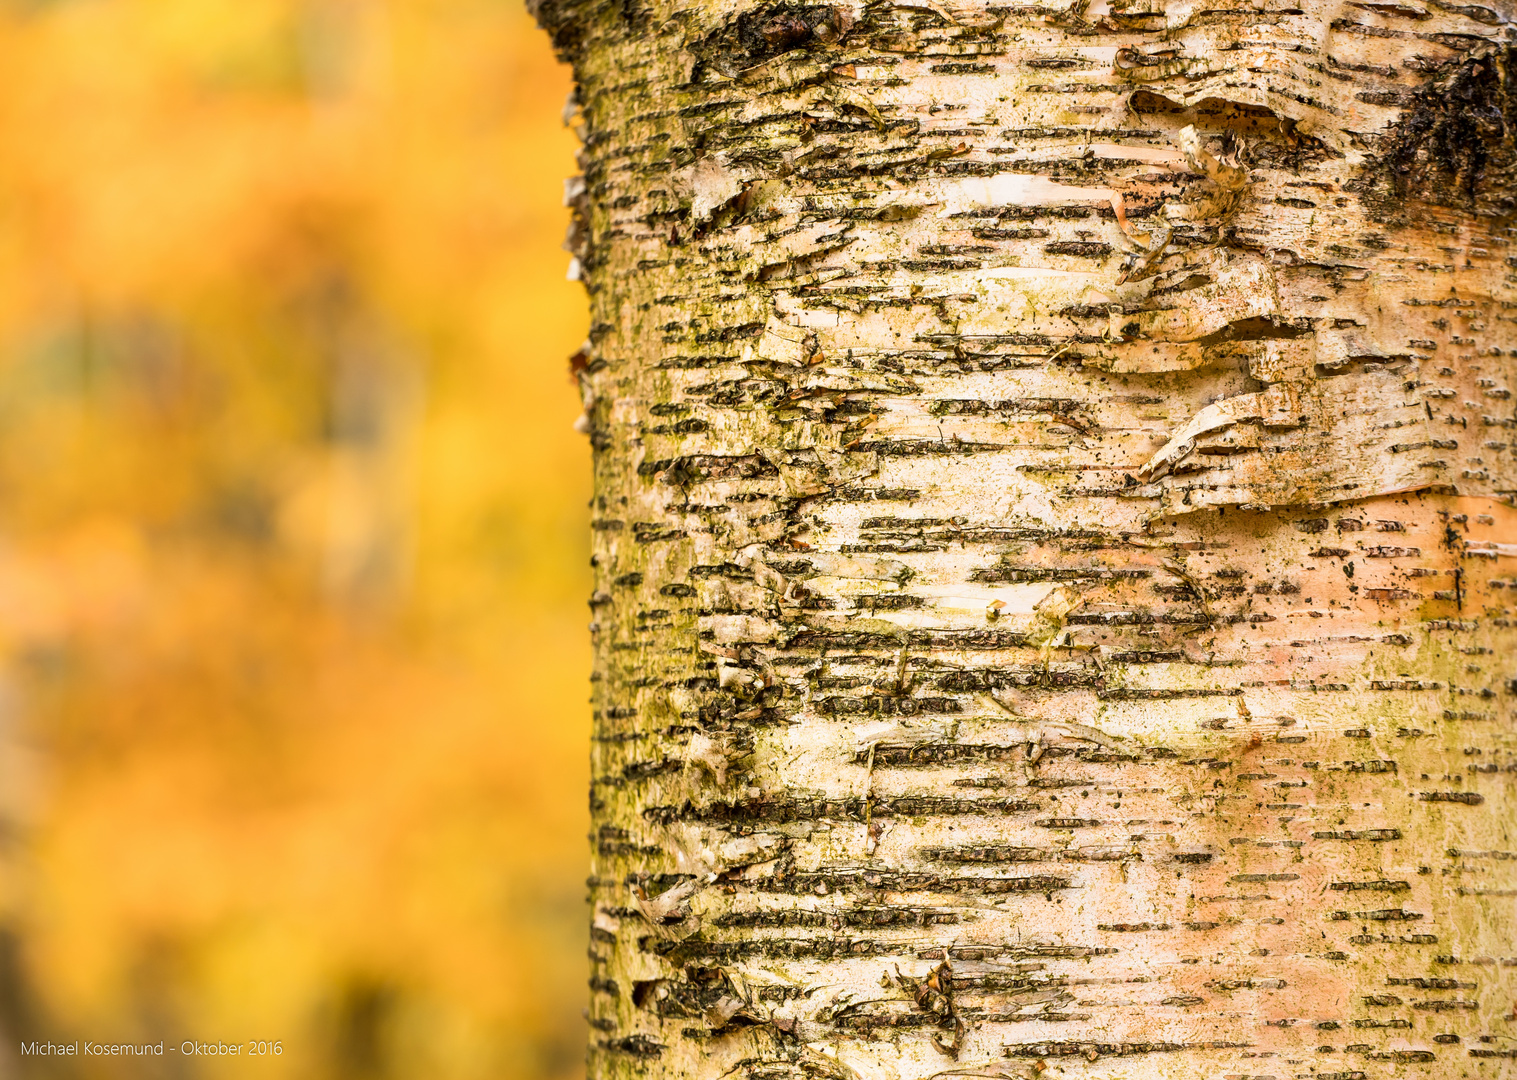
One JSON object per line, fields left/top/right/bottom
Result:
{"left": 0, "top": 0, "right": 589, "bottom": 1080}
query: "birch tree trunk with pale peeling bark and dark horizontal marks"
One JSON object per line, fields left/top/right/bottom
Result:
{"left": 537, "top": 0, "right": 1517, "bottom": 1080}
